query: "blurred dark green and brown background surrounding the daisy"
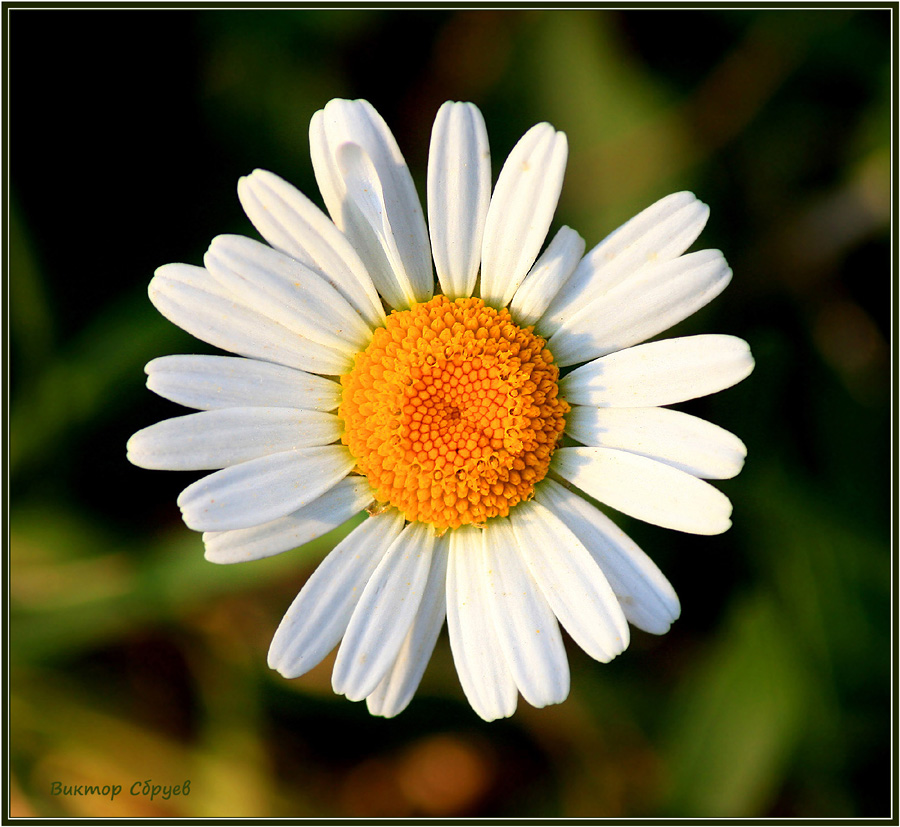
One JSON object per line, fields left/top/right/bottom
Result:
{"left": 7, "top": 9, "right": 892, "bottom": 818}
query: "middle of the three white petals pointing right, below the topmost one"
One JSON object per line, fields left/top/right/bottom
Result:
{"left": 566, "top": 405, "right": 747, "bottom": 480}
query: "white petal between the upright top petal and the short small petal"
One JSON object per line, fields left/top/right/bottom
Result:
{"left": 481, "top": 123, "right": 568, "bottom": 307}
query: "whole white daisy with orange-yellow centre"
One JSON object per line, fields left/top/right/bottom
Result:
{"left": 128, "top": 100, "right": 753, "bottom": 720}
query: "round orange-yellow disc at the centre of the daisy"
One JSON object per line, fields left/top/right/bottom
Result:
{"left": 338, "top": 296, "right": 569, "bottom": 531}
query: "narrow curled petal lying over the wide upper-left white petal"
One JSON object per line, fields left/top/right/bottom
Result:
{"left": 336, "top": 143, "right": 433, "bottom": 308}
